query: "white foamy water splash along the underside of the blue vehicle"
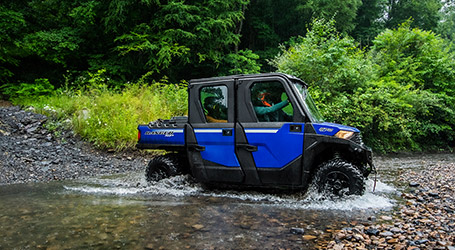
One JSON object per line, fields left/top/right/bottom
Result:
{"left": 64, "top": 173, "right": 395, "bottom": 211}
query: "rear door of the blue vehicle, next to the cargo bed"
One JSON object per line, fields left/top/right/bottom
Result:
{"left": 185, "top": 79, "right": 244, "bottom": 183}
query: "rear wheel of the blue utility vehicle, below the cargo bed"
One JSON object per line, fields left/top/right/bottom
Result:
{"left": 145, "top": 154, "right": 179, "bottom": 182}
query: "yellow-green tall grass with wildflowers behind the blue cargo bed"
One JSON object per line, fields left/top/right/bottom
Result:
{"left": 17, "top": 78, "right": 188, "bottom": 151}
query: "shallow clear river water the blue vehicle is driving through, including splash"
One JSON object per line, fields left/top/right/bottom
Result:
{"left": 0, "top": 153, "right": 453, "bottom": 249}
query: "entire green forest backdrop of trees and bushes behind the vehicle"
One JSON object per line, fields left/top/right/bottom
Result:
{"left": 0, "top": 0, "right": 455, "bottom": 151}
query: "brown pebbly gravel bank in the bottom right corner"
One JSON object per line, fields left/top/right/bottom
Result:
{"left": 324, "top": 156, "right": 455, "bottom": 250}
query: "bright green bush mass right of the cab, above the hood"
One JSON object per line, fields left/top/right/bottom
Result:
{"left": 273, "top": 21, "right": 455, "bottom": 151}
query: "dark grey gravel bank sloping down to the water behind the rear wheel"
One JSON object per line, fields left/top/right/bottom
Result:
{"left": 0, "top": 106, "right": 146, "bottom": 185}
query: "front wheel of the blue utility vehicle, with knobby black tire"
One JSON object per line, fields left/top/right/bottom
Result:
{"left": 313, "top": 159, "right": 365, "bottom": 197}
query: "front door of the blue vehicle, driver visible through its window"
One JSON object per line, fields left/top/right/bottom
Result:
{"left": 235, "top": 76, "right": 305, "bottom": 186}
